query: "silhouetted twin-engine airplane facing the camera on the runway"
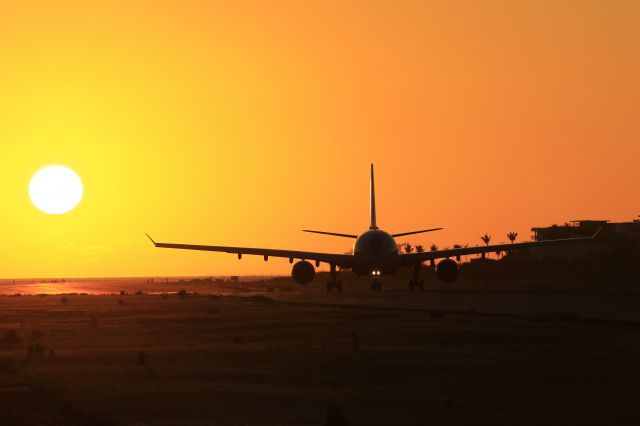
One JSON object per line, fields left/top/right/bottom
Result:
{"left": 147, "top": 164, "right": 600, "bottom": 292}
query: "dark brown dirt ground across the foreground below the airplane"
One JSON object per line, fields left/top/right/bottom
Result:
{"left": 0, "top": 274, "right": 640, "bottom": 425}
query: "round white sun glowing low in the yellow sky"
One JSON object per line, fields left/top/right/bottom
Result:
{"left": 29, "top": 166, "right": 84, "bottom": 214}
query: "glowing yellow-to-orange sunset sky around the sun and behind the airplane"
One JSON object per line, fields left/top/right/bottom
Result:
{"left": 0, "top": 0, "right": 640, "bottom": 277}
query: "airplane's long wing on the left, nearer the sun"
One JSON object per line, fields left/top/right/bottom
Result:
{"left": 147, "top": 234, "right": 353, "bottom": 268}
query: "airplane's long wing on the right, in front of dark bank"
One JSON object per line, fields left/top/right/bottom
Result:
{"left": 399, "top": 230, "right": 600, "bottom": 265}
